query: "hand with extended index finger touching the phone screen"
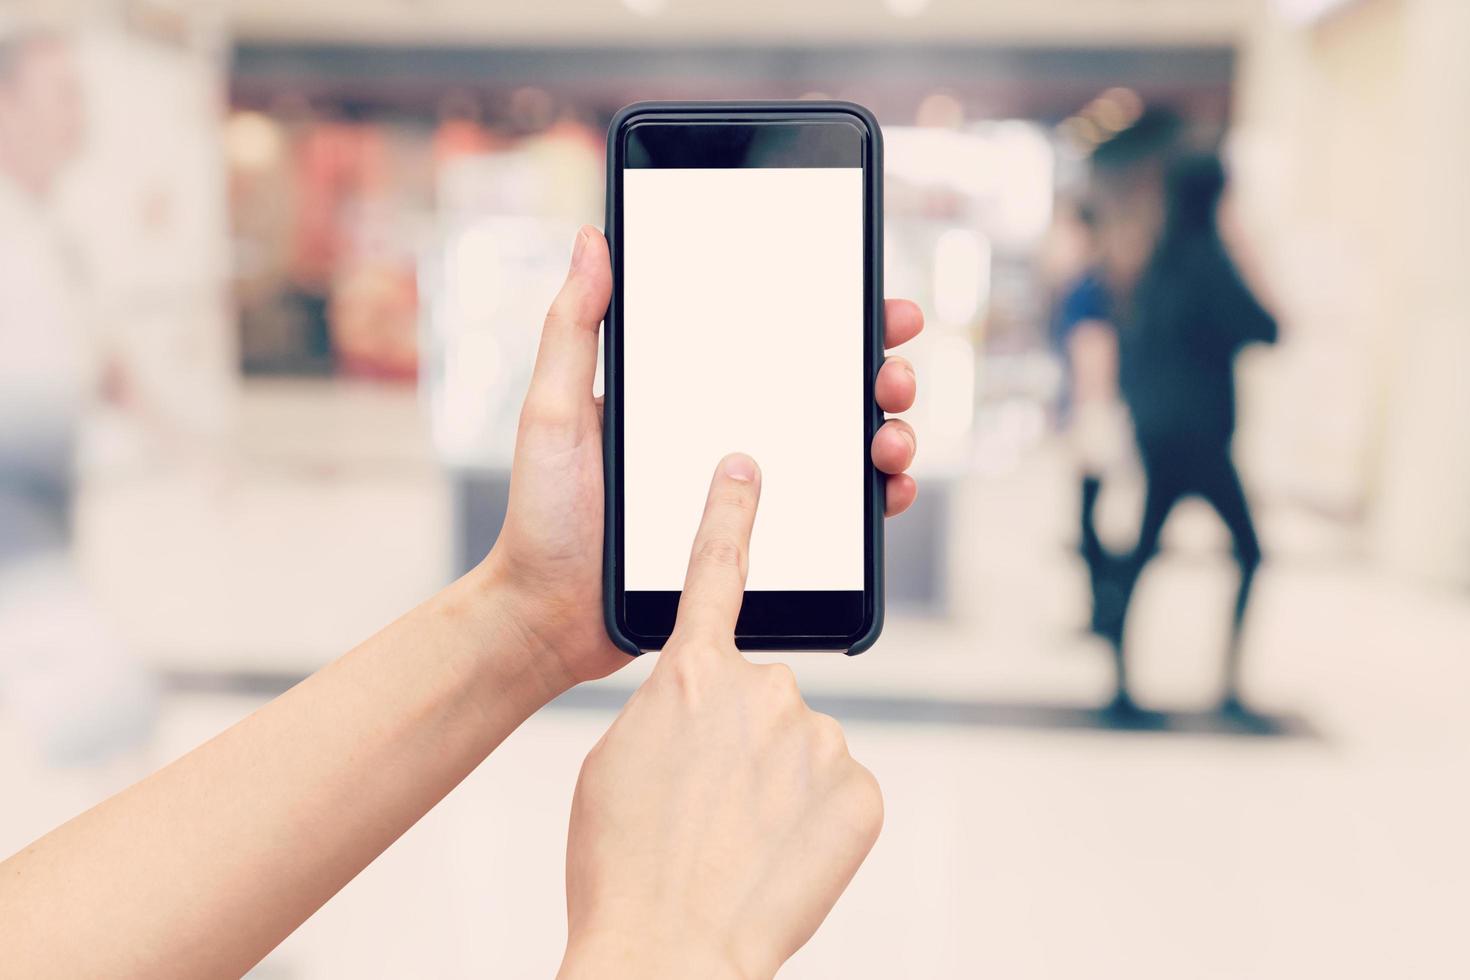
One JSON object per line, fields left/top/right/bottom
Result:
{"left": 562, "top": 455, "right": 883, "bottom": 980}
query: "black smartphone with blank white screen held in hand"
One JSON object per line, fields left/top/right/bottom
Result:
{"left": 603, "top": 101, "right": 885, "bottom": 654}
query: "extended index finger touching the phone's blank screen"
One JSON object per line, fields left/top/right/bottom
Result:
{"left": 675, "top": 453, "right": 760, "bottom": 644}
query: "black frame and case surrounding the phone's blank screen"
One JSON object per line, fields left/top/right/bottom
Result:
{"left": 603, "top": 101, "right": 885, "bottom": 654}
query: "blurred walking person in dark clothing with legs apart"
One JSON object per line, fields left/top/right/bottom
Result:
{"left": 1103, "top": 153, "right": 1277, "bottom": 714}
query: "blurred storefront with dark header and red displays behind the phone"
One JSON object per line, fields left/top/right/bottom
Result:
{"left": 217, "top": 41, "right": 1233, "bottom": 640}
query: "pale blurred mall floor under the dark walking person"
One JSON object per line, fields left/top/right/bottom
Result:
{"left": 0, "top": 449, "right": 1470, "bottom": 980}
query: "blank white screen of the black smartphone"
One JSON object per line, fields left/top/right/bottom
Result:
{"left": 623, "top": 167, "right": 864, "bottom": 592}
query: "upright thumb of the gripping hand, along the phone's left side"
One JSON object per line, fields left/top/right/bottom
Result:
{"left": 526, "top": 225, "right": 613, "bottom": 419}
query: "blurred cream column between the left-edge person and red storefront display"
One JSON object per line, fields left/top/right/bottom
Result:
{"left": 62, "top": 11, "right": 240, "bottom": 443}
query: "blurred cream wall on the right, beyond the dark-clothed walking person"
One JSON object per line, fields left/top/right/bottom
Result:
{"left": 1232, "top": 0, "right": 1470, "bottom": 586}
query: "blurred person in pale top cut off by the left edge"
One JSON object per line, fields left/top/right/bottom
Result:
{"left": 0, "top": 25, "right": 154, "bottom": 764}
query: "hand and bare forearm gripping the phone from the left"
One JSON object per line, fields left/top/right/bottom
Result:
{"left": 0, "top": 228, "right": 922, "bottom": 979}
